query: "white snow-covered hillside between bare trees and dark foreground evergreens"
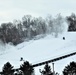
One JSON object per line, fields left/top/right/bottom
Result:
{"left": 0, "top": 32, "right": 76, "bottom": 75}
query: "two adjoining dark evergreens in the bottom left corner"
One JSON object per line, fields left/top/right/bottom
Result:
{"left": 0, "top": 61, "right": 34, "bottom": 75}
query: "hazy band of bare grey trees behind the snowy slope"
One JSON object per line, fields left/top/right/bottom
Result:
{"left": 0, "top": 13, "right": 76, "bottom": 45}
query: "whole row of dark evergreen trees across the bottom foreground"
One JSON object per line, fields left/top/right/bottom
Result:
{"left": 0, "top": 61, "right": 76, "bottom": 75}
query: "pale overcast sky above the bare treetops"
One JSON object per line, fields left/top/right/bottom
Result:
{"left": 0, "top": 0, "right": 76, "bottom": 23}
